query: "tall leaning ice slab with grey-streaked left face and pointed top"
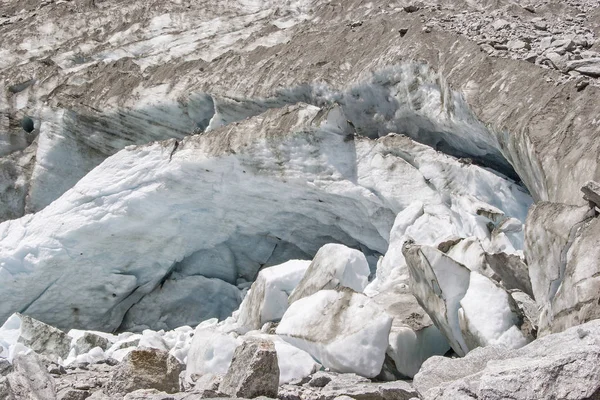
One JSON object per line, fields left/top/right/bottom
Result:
{"left": 402, "top": 242, "right": 471, "bottom": 356}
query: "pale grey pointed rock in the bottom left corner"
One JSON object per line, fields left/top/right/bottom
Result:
{"left": 6, "top": 352, "right": 56, "bottom": 400}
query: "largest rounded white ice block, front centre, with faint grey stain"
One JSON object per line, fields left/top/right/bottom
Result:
{"left": 276, "top": 289, "right": 392, "bottom": 377}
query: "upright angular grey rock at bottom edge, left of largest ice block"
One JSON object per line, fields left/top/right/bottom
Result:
{"left": 219, "top": 339, "right": 279, "bottom": 399}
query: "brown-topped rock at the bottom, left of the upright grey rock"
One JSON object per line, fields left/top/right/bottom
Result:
{"left": 107, "top": 349, "right": 182, "bottom": 395}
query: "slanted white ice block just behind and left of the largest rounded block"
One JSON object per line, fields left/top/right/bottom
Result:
{"left": 238, "top": 260, "right": 311, "bottom": 329}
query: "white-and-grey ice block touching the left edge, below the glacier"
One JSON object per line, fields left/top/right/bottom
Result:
{"left": 0, "top": 313, "right": 71, "bottom": 359}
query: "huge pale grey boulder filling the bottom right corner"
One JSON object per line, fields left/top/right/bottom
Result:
{"left": 414, "top": 320, "right": 600, "bottom": 400}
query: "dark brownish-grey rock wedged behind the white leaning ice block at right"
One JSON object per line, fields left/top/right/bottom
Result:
{"left": 485, "top": 253, "right": 533, "bottom": 297}
